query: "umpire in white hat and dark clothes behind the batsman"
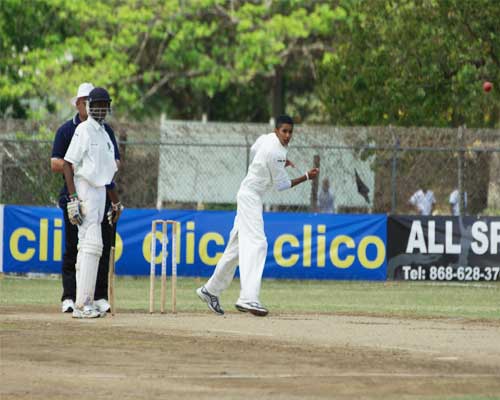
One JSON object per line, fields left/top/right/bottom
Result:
{"left": 50, "top": 83, "right": 122, "bottom": 313}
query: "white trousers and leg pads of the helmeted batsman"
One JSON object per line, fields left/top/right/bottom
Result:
{"left": 75, "top": 177, "right": 106, "bottom": 308}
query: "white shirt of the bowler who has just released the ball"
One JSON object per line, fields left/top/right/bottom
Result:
{"left": 240, "top": 132, "right": 292, "bottom": 197}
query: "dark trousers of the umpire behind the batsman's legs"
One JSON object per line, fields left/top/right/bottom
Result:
{"left": 61, "top": 207, "right": 113, "bottom": 301}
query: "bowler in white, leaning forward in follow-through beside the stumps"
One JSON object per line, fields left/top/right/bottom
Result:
{"left": 196, "top": 115, "right": 319, "bottom": 316}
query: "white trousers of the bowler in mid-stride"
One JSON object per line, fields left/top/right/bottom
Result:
{"left": 205, "top": 190, "right": 267, "bottom": 302}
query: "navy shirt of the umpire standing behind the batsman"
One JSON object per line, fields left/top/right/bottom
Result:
{"left": 51, "top": 113, "right": 120, "bottom": 208}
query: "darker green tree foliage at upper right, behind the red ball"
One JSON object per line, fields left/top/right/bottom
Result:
{"left": 320, "top": 0, "right": 500, "bottom": 127}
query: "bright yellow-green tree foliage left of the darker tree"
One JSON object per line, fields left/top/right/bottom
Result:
{"left": 0, "top": 0, "right": 345, "bottom": 120}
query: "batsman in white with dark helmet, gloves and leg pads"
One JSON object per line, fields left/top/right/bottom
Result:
{"left": 63, "top": 88, "right": 122, "bottom": 318}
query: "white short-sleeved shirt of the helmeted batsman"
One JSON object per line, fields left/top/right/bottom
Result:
{"left": 64, "top": 116, "right": 117, "bottom": 187}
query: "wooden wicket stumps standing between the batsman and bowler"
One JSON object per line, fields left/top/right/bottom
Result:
{"left": 149, "top": 219, "right": 177, "bottom": 314}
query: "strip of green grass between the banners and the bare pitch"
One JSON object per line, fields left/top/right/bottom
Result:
{"left": 0, "top": 276, "right": 500, "bottom": 320}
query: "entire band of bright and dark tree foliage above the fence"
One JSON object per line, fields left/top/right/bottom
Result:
{"left": 0, "top": 0, "right": 500, "bottom": 127}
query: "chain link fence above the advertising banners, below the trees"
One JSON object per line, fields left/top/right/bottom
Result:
{"left": 0, "top": 119, "right": 500, "bottom": 215}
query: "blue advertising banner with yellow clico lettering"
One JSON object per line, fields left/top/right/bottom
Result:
{"left": 0, "top": 205, "right": 387, "bottom": 280}
